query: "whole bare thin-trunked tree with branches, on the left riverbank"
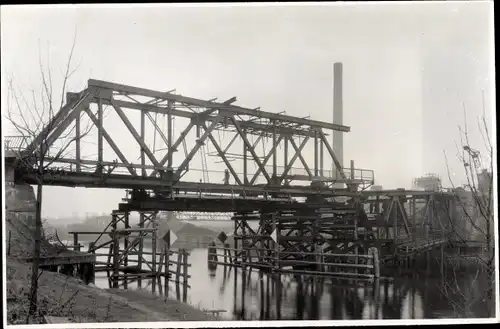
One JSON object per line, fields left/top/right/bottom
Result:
{"left": 6, "top": 31, "right": 95, "bottom": 323}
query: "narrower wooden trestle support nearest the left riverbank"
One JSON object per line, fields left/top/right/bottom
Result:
{"left": 70, "top": 210, "right": 191, "bottom": 300}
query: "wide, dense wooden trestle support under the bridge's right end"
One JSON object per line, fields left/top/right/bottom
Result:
{"left": 225, "top": 191, "right": 454, "bottom": 277}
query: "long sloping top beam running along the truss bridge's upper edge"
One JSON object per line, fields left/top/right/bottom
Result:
{"left": 88, "top": 79, "right": 350, "bottom": 132}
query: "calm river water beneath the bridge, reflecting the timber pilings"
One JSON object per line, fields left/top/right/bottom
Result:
{"left": 71, "top": 221, "right": 487, "bottom": 320}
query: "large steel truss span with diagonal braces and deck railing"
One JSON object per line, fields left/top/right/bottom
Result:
{"left": 6, "top": 80, "right": 374, "bottom": 200}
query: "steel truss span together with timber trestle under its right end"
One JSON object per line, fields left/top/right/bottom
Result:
{"left": 5, "top": 79, "right": 453, "bottom": 280}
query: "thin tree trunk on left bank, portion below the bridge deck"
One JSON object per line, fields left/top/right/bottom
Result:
{"left": 27, "top": 178, "right": 43, "bottom": 323}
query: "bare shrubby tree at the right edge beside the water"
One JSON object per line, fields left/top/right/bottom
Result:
{"left": 444, "top": 94, "right": 495, "bottom": 316}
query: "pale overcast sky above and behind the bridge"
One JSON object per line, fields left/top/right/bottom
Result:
{"left": 1, "top": 1, "right": 494, "bottom": 216}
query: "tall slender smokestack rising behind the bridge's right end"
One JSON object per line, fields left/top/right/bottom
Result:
{"left": 332, "top": 62, "right": 344, "bottom": 173}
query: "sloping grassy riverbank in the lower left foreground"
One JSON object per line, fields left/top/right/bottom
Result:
{"left": 7, "top": 257, "right": 216, "bottom": 325}
